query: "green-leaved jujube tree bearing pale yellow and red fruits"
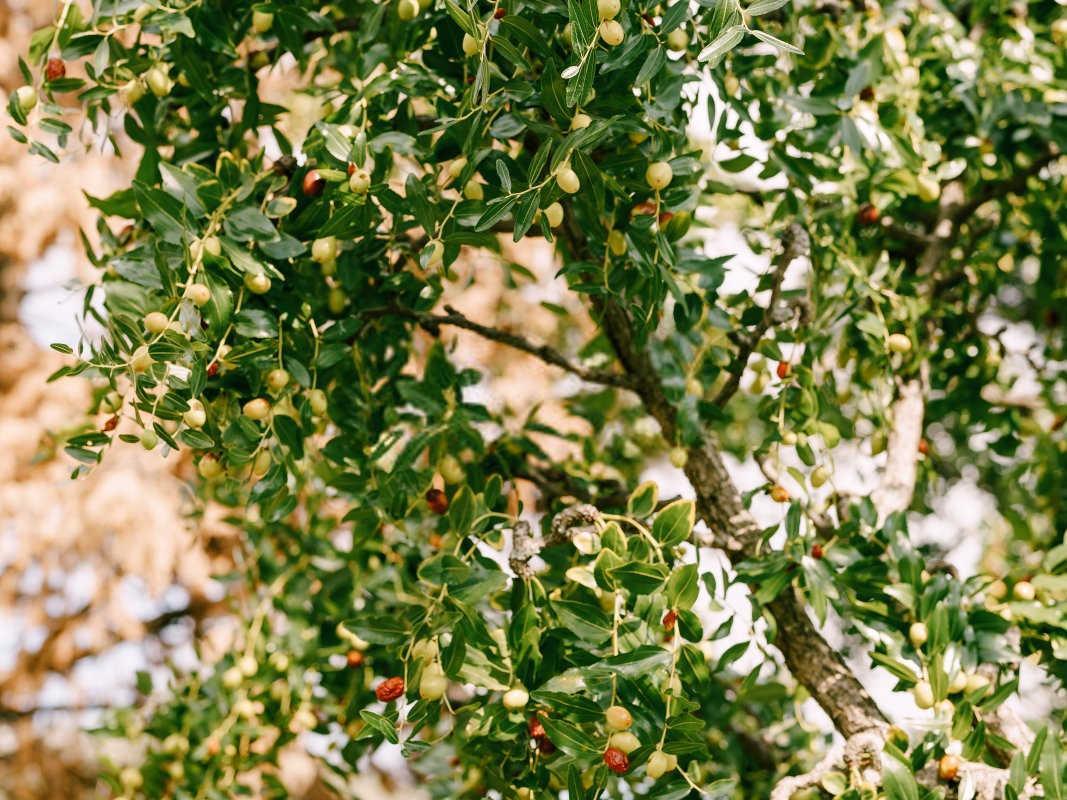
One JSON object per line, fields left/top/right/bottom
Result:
{"left": 9, "top": 0, "right": 1067, "bottom": 800}
